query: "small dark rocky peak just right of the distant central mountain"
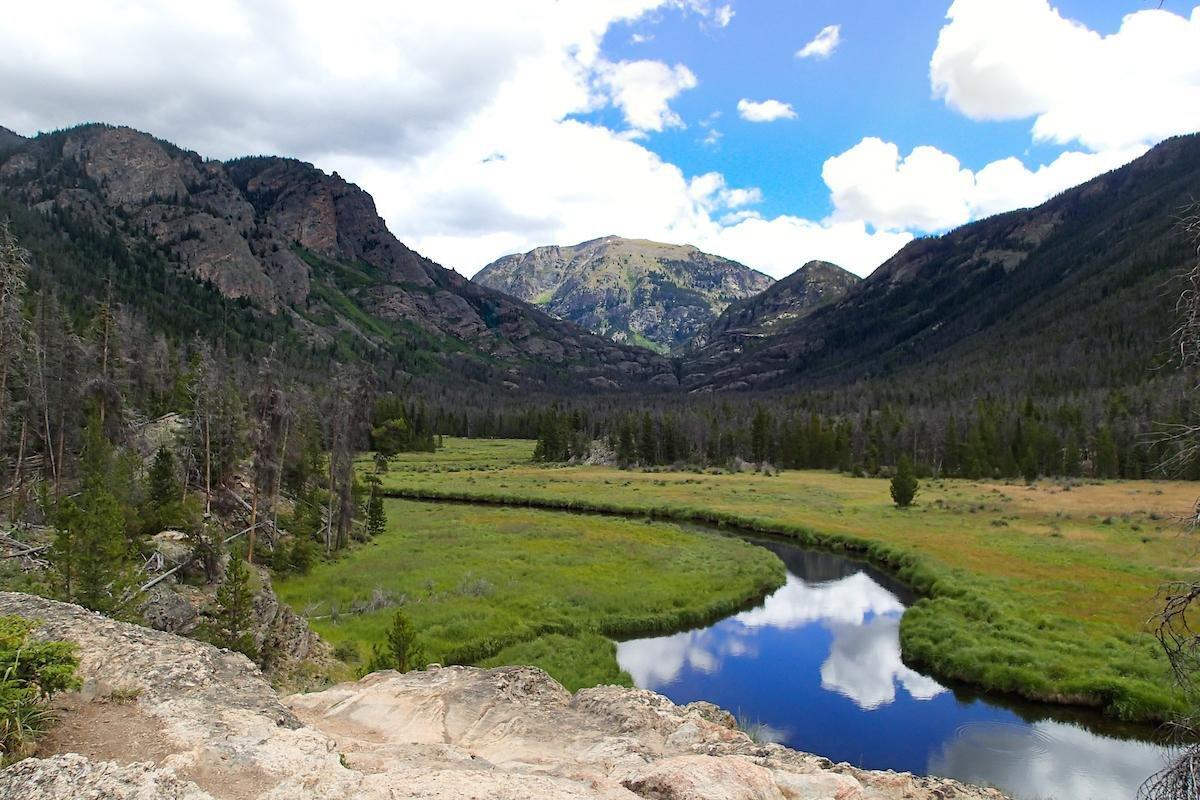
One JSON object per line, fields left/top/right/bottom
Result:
{"left": 694, "top": 261, "right": 862, "bottom": 353}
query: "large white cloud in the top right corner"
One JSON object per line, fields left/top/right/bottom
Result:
{"left": 930, "top": 0, "right": 1200, "bottom": 151}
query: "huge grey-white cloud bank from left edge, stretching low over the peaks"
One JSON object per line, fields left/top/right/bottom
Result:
{"left": 0, "top": 0, "right": 1156, "bottom": 287}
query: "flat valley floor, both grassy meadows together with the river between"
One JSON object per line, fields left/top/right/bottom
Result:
{"left": 267, "top": 439, "right": 1193, "bottom": 799}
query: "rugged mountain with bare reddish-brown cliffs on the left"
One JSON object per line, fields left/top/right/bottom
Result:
{"left": 0, "top": 125, "right": 676, "bottom": 389}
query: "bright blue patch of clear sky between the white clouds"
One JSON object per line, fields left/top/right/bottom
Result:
{"left": 595, "top": 0, "right": 1166, "bottom": 225}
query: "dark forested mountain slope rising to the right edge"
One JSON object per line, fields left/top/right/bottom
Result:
{"left": 684, "top": 136, "right": 1200, "bottom": 397}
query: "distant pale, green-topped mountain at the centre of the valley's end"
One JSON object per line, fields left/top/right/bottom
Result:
{"left": 474, "top": 236, "right": 772, "bottom": 353}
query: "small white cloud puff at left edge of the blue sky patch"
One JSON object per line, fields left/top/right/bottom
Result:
{"left": 598, "top": 60, "right": 698, "bottom": 131}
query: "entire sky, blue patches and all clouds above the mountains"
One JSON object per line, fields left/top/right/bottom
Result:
{"left": 0, "top": 0, "right": 1200, "bottom": 277}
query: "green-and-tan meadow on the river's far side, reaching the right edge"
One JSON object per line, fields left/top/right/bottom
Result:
{"left": 369, "top": 440, "right": 1198, "bottom": 721}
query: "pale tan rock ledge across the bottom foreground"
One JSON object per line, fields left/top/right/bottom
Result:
{"left": 0, "top": 593, "right": 1003, "bottom": 800}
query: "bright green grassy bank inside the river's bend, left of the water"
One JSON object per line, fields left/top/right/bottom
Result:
{"left": 276, "top": 500, "right": 784, "bottom": 688}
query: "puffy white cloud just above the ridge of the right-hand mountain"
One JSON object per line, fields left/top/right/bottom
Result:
{"left": 822, "top": 137, "right": 1146, "bottom": 233}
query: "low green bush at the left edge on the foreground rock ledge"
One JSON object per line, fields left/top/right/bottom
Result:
{"left": 0, "top": 616, "right": 79, "bottom": 765}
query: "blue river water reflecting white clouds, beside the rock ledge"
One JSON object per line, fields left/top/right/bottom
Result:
{"left": 617, "top": 539, "right": 1164, "bottom": 800}
